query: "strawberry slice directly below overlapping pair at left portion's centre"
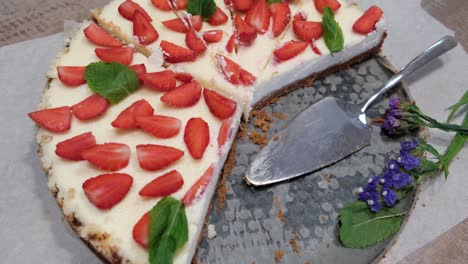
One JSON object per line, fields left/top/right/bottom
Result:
{"left": 136, "top": 144, "right": 184, "bottom": 171}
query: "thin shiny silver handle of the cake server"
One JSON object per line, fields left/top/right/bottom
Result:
{"left": 361, "top": 36, "right": 457, "bottom": 113}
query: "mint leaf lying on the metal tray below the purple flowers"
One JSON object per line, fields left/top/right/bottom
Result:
{"left": 339, "top": 201, "right": 403, "bottom": 248}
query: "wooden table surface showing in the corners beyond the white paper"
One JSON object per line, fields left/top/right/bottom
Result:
{"left": 0, "top": 0, "right": 468, "bottom": 264}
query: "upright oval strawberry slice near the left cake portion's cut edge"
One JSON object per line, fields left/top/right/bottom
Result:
{"left": 184, "top": 118, "right": 210, "bottom": 160}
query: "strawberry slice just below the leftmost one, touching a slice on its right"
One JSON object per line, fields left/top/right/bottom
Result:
{"left": 55, "top": 132, "right": 96, "bottom": 160}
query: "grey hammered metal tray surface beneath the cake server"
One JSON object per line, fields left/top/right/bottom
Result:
{"left": 196, "top": 57, "right": 415, "bottom": 264}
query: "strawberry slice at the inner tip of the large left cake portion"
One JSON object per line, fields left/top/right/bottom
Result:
{"left": 203, "top": 89, "right": 237, "bottom": 119}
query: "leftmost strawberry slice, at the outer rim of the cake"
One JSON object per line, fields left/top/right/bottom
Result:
{"left": 28, "top": 106, "right": 72, "bottom": 132}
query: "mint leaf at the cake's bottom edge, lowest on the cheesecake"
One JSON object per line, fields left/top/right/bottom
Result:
{"left": 148, "top": 197, "right": 188, "bottom": 264}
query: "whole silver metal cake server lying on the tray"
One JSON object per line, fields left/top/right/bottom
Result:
{"left": 246, "top": 36, "right": 457, "bottom": 186}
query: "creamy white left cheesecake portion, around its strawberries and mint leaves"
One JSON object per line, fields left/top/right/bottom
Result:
{"left": 37, "top": 22, "right": 241, "bottom": 263}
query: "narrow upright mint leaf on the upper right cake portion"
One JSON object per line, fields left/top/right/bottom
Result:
{"left": 322, "top": 7, "right": 344, "bottom": 53}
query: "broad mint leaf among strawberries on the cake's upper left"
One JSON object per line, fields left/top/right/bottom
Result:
{"left": 85, "top": 62, "right": 140, "bottom": 104}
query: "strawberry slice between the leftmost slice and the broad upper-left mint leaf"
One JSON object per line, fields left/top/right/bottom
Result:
{"left": 71, "top": 94, "right": 109, "bottom": 120}
